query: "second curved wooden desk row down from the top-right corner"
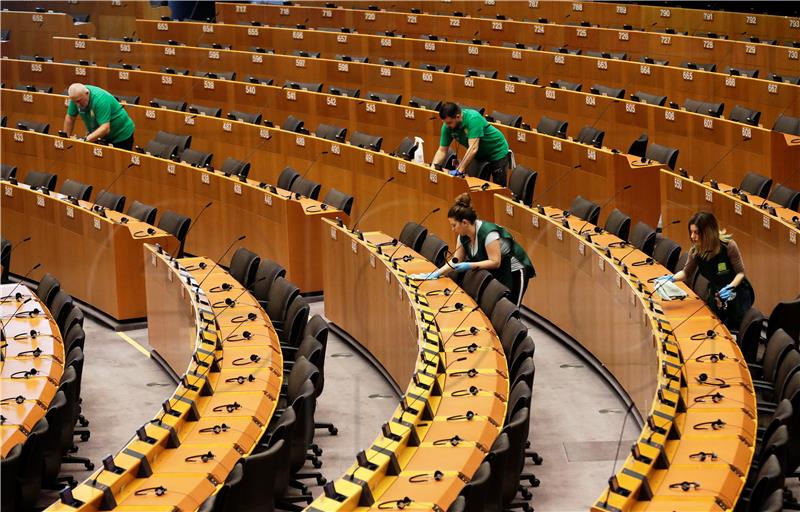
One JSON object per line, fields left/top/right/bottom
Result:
{"left": 217, "top": 3, "right": 798, "bottom": 78}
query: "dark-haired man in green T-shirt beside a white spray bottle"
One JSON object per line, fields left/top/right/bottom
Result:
{"left": 433, "top": 102, "right": 510, "bottom": 186}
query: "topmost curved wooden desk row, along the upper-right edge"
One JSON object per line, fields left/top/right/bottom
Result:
{"left": 302, "top": 0, "right": 800, "bottom": 45}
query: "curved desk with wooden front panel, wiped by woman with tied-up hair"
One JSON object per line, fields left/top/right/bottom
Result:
{"left": 307, "top": 220, "right": 509, "bottom": 512}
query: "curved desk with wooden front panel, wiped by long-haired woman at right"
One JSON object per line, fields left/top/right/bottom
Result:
{"left": 495, "top": 196, "right": 757, "bottom": 511}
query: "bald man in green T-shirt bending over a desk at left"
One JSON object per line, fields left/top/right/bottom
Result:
{"left": 64, "top": 84, "right": 135, "bottom": 150}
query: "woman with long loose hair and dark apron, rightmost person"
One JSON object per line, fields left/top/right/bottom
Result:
{"left": 658, "top": 212, "right": 755, "bottom": 330}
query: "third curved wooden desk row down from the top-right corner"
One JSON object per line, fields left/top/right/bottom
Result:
{"left": 136, "top": 20, "right": 800, "bottom": 126}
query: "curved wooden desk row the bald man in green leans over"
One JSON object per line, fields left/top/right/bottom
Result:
{"left": 0, "top": 126, "right": 345, "bottom": 294}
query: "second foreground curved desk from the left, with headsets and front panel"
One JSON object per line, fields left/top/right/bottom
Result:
{"left": 47, "top": 245, "right": 283, "bottom": 512}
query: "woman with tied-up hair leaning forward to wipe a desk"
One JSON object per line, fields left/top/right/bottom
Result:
{"left": 411, "top": 193, "right": 536, "bottom": 306}
